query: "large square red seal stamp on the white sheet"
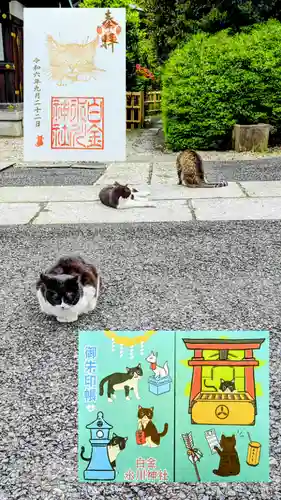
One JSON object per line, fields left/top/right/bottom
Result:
{"left": 51, "top": 97, "right": 104, "bottom": 150}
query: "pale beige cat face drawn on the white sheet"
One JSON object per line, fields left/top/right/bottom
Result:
{"left": 47, "top": 35, "right": 105, "bottom": 86}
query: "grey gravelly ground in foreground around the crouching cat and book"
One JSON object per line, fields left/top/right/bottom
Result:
{"left": 0, "top": 221, "right": 281, "bottom": 500}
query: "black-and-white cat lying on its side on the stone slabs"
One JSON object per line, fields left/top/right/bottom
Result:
{"left": 99, "top": 181, "right": 155, "bottom": 208}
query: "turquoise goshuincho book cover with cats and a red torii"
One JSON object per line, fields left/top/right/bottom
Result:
{"left": 78, "top": 330, "right": 269, "bottom": 482}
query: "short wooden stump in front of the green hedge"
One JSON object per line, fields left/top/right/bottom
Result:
{"left": 232, "top": 123, "right": 271, "bottom": 152}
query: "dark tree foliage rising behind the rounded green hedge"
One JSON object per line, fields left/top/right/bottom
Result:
{"left": 139, "top": 0, "right": 281, "bottom": 63}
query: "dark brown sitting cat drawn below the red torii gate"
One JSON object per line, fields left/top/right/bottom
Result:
{"left": 213, "top": 434, "right": 240, "bottom": 477}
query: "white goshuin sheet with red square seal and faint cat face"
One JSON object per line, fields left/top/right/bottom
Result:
{"left": 24, "top": 8, "right": 126, "bottom": 162}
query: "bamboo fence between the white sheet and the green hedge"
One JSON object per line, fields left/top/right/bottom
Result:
{"left": 126, "top": 91, "right": 161, "bottom": 130}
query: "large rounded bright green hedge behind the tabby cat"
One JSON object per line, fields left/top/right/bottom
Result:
{"left": 161, "top": 20, "right": 281, "bottom": 151}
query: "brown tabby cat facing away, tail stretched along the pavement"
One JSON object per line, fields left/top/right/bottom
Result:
{"left": 176, "top": 149, "right": 228, "bottom": 187}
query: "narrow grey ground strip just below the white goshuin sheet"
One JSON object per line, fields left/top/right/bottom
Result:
{"left": 0, "top": 167, "right": 105, "bottom": 187}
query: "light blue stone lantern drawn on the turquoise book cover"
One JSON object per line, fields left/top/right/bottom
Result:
{"left": 81, "top": 411, "right": 115, "bottom": 481}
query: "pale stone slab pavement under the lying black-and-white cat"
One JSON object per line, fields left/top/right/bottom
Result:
{"left": 0, "top": 162, "right": 281, "bottom": 225}
